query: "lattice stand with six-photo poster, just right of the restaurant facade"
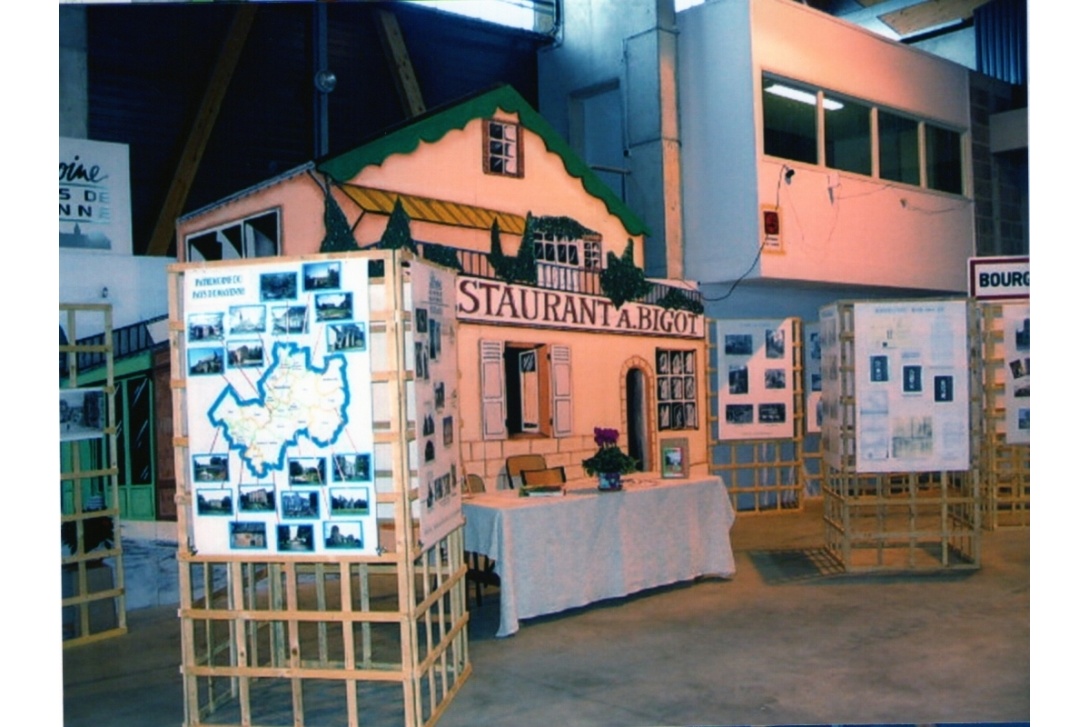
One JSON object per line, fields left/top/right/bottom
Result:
{"left": 707, "top": 318, "right": 808, "bottom": 514}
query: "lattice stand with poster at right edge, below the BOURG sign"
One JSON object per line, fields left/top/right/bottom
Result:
{"left": 978, "top": 302, "right": 1030, "bottom": 530}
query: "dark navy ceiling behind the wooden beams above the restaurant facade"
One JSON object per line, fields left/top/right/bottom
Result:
{"left": 75, "top": 2, "right": 549, "bottom": 254}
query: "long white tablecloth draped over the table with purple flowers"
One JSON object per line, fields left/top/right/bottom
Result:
{"left": 462, "top": 475, "right": 735, "bottom": 637}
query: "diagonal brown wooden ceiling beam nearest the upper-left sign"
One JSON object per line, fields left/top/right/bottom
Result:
{"left": 147, "top": 4, "right": 257, "bottom": 255}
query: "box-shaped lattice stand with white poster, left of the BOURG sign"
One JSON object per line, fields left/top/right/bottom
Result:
{"left": 822, "top": 301, "right": 981, "bottom": 573}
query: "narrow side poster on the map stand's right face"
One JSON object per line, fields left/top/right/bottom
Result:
{"left": 408, "top": 262, "right": 463, "bottom": 548}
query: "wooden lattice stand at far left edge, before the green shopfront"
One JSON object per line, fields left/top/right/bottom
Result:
{"left": 60, "top": 303, "right": 128, "bottom": 647}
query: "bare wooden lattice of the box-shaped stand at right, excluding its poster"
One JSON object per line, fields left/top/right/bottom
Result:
{"left": 823, "top": 303, "right": 981, "bottom": 573}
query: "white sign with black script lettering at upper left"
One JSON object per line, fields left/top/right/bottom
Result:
{"left": 58, "top": 136, "right": 133, "bottom": 255}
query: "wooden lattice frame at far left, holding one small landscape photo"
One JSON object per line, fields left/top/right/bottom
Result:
{"left": 60, "top": 303, "right": 128, "bottom": 649}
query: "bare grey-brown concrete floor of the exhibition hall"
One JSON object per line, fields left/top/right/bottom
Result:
{"left": 63, "top": 504, "right": 1030, "bottom": 727}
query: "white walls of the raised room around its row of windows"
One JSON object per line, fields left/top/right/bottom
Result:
{"left": 678, "top": 0, "right": 973, "bottom": 292}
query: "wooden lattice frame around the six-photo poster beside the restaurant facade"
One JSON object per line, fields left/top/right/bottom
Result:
{"left": 707, "top": 318, "right": 808, "bottom": 516}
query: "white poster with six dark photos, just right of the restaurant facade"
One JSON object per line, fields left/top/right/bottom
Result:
{"left": 715, "top": 318, "right": 795, "bottom": 440}
